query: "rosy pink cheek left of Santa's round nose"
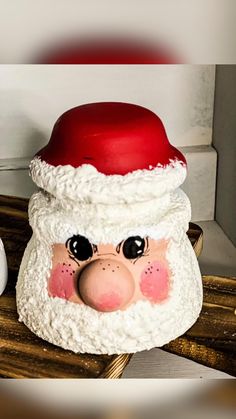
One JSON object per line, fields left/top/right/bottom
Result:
{"left": 48, "top": 263, "right": 75, "bottom": 300}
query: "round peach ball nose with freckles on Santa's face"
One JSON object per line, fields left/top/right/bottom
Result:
{"left": 78, "top": 259, "right": 135, "bottom": 311}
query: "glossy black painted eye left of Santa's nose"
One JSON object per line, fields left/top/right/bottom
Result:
{"left": 66, "top": 234, "right": 93, "bottom": 261}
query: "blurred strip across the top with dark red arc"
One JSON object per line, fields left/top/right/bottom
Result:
{"left": 0, "top": 0, "right": 236, "bottom": 64}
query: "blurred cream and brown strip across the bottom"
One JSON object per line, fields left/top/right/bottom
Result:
{"left": 0, "top": 379, "right": 236, "bottom": 419}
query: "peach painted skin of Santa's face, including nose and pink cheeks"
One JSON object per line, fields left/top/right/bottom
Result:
{"left": 48, "top": 235, "right": 171, "bottom": 312}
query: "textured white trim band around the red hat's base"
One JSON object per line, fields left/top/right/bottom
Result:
{"left": 30, "top": 157, "right": 187, "bottom": 205}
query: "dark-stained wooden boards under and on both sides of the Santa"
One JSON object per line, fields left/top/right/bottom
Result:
{"left": 0, "top": 196, "right": 236, "bottom": 378}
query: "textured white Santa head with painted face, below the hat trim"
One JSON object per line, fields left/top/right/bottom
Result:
{"left": 16, "top": 170, "right": 202, "bottom": 354}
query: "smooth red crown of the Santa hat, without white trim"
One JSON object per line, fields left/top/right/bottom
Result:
{"left": 37, "top": 102, "right": 186, "bottom": 175}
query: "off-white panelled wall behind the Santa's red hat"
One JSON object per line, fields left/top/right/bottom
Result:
{"left": 0, "top": 65, "right": 216, "bottom": 220}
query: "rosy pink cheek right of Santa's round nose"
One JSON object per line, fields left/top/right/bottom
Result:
{"left": 140, "top": 262, "right": 169, "bottom": 303}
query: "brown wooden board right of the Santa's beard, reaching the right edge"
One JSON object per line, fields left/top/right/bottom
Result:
{"left": 163, "top": 276, "right": 236, "bottom": 376}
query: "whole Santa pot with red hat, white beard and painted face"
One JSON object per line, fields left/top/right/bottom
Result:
{"left": 16, "top": 102, "right": 202, "bottom": 354}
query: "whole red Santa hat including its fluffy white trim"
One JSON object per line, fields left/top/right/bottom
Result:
{"left": 30, "top": 102, "right": 186, "bottom": 204}
